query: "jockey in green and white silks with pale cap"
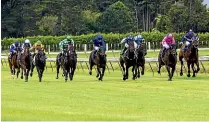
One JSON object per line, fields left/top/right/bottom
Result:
{"left": 58, "top": 36, "right": 77, "bottom": 64}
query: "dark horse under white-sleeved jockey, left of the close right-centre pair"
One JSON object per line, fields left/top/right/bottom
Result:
{"left": 120, "top": 41, "right": 137, "bottom": 80}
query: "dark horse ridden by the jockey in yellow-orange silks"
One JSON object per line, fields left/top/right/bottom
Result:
{"left": 30, "top": 49, "right": 46, "bottom": 82}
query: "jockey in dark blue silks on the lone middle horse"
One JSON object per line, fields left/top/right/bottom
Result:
{"left": 92, "top": 35, "right": 106, "bottom": 56}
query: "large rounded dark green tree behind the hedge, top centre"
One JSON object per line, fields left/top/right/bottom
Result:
{"left": 100, "top": 1, "right": 134, "bottom": 33}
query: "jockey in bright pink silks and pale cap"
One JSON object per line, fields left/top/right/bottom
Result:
{"left": 161, "top": 33, "right": 175, "bottom": 57}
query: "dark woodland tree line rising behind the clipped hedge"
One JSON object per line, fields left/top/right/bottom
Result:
{"left": 1, "top": 0, "right": 209, "bottom": 38}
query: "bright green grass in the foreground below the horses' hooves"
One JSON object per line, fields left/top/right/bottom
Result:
{"left": 1, "top": 68, "right": 209, "bottom": 120}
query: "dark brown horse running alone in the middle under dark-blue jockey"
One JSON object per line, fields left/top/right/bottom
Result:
{"left": 89, "top": 46, "right": 107, "bottom": 81}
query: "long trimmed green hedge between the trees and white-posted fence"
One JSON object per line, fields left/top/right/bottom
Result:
{"left": 1, "top": 32, "right": 209, "bottom": 46}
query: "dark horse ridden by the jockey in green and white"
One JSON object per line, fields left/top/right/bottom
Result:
{"left": 63, "top": 45, "right": 77, "bottom": 82}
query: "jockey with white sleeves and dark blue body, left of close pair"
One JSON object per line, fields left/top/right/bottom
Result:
{"left": 120, "top": 35, "right": 137, "bottom": 55}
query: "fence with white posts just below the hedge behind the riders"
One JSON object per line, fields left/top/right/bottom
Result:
{"left": 1, "top": 41, "right": 209, "bottom": 52}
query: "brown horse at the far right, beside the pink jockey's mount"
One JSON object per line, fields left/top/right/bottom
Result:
{"left": 179, "top": 36, "right": 200, "bottom": 77}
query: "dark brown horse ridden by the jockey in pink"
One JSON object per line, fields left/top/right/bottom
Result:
{"left": 158, "top": 44, "right": 177, "bottom": 81}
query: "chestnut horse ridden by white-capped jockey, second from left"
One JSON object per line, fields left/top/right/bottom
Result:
{"left": 20, "top": 46, "right": 32, "bottom": 82}
